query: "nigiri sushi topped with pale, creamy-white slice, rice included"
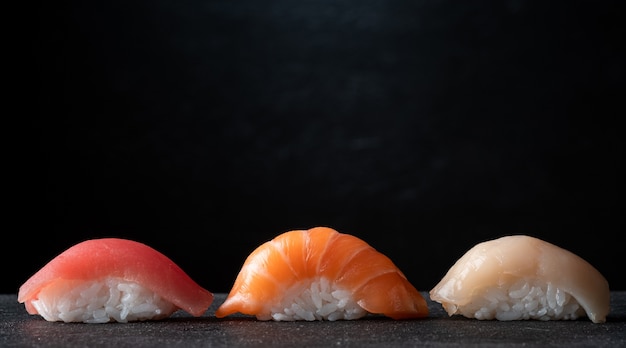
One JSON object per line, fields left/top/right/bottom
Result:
{"left": 429, "top": 235, "right": 610, "bottom": 323}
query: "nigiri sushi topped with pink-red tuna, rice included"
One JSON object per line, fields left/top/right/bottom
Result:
{"left": 17, "top": 238, "right": 213, "bottom": 323}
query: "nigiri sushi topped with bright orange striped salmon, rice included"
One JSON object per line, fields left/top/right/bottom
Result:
{"left": 215, "top": 227, "right": 428, "bottom": 321}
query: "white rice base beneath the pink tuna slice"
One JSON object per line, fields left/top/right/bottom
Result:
{"left": 32, "top": 277, "right": 178, "bottom": 324}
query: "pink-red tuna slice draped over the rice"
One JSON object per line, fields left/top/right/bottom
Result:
{"left": 17, "top": 238, "right": 213, "bottom": 317}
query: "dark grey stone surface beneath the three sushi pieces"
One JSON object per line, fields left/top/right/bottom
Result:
{"left": 0, "top": 291, "right": 626, "bottom": 348}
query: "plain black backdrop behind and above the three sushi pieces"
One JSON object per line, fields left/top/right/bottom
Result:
{"left": 8, "top": 0, "right": 626, "bottom": 293}
